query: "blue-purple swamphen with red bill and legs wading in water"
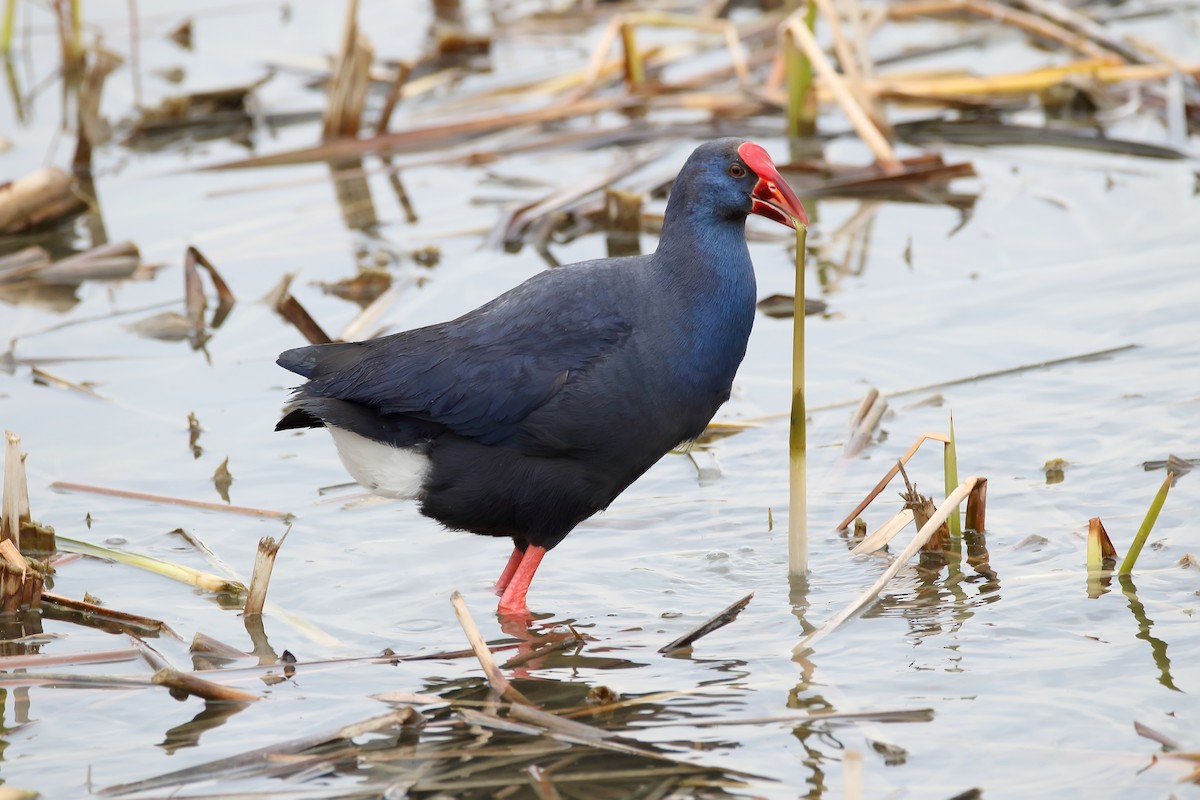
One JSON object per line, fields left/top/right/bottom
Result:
{"left": 276, "top": 138, "right": 809, "bottom": 619}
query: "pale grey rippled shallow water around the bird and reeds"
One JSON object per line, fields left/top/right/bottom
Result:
{"left": 0, "top": 1, "right": 1200, "bottom": 798}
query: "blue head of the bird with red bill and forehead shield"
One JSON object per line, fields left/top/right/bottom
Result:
{"left": 679, "top": 139, "right": 809, "bottom": 228}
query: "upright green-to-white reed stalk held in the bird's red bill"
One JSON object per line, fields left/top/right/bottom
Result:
{"left": 787, "top": 223, "right": 809, "bottom": 575}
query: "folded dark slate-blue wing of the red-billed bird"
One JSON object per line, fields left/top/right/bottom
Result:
{"left": 280, "top": 267, "right": 631, "bottom": 444}
